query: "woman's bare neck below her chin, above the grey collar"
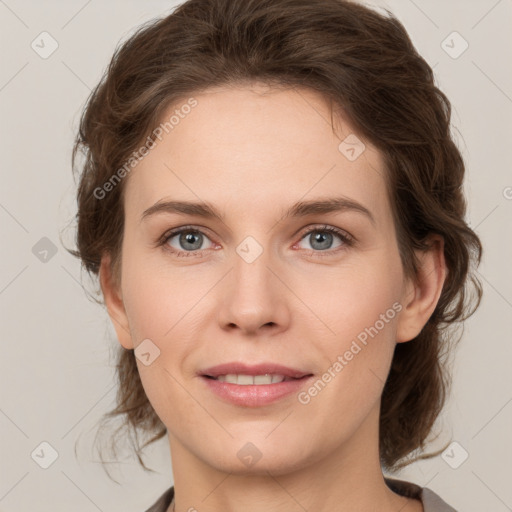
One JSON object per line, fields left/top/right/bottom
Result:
{"left": 168, "top": 404, "right": 423, "bottom": 512}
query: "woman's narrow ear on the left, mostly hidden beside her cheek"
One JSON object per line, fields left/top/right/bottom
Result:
{"left": 99, "top": 254, "right": 134, "bottom": 349}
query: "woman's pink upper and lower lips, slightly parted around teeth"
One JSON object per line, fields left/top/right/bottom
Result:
{"left": 199, "top": 363, "right": 313, "bottom": 407}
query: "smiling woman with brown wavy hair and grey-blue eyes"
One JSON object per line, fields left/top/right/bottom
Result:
{"left": 73, "top": 0, "right": 481, "bottom": 512}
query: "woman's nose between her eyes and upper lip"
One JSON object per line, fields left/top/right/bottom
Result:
{"left": 218, "top": 244, "right": 290, "bottom": 335}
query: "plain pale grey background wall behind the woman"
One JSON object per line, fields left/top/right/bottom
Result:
{"left": 0, "top": 0, "right": 512, "bottom": 512}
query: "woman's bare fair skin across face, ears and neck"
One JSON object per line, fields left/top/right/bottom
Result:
{"left": 100, "top": 84, "right": 446, "bottom": 512}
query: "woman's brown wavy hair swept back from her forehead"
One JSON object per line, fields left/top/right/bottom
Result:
{"left": 70, "top": 0, "right": 482, "bottom": 471}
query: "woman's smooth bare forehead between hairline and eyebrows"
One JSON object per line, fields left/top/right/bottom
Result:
{"left": 125, "top": 84, "right": 389, "bottom": 222}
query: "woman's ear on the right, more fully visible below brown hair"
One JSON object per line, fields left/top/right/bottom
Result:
{"left": 396, "top": 235, "right": 447, "bottom": 343}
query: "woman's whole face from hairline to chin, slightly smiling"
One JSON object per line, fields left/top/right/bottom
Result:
{"left": 105, "top": 85, "right": 424, "bottom": 474}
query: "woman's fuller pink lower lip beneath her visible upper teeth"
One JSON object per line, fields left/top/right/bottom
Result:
{"left": 201, "top": 375, "right": 313, "bottom": 407}
